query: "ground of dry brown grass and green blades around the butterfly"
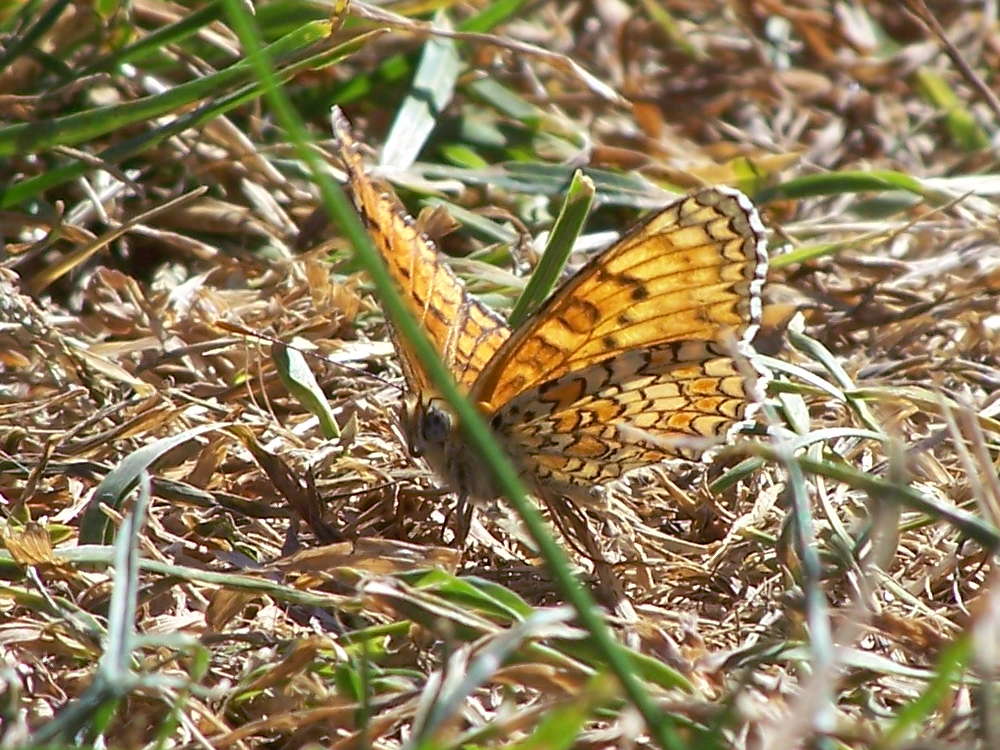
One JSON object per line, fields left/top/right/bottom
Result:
{"left": 0, "top": 0, "right": 1000, "bottom": 750}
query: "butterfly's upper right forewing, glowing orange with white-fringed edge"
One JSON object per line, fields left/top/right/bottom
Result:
{"left": 472, "top": 188, "right": 767, "bottom": 413}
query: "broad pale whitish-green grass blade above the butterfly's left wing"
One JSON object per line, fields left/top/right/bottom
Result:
{"left": 379, "top": 12, "right": 461, "bottom": 170}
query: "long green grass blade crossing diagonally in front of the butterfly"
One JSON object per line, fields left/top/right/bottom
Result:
{"left": 224, "top": 0, "right": 684, "bottom": 750}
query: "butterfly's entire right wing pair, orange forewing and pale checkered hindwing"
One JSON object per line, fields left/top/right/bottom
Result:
{"left": 473, "top": 188, "right": 767, "bottom": 497}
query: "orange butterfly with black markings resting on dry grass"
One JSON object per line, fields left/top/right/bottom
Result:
{"left": 333, "top": 111, "right": 767, "bottom": 536}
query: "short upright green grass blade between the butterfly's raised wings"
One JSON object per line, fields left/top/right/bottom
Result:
{"left": 510, "top": 170, "right": 594, "bottom": 328}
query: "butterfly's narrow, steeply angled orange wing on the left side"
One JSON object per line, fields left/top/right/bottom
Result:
{"left": 333, "top": 109, "right": 510, "bottom": 395}
